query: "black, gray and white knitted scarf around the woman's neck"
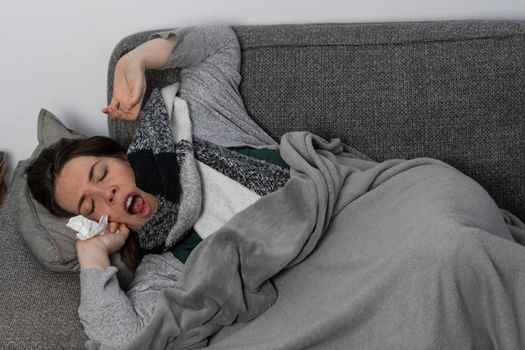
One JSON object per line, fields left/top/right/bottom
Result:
{"left": 128, "top": 89, "right": 289, "bottom": 252}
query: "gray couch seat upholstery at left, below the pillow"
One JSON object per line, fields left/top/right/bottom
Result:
{"left": 0, "top": 165, "right": 87, "bottom": 350}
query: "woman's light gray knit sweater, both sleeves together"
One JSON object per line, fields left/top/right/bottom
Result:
{"left": 78, "top": 26, "right": 277, "bottom": 346}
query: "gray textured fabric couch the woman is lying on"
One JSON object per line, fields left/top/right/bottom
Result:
{"left": 0, "top": 21, "right": 525, "bottom": 349}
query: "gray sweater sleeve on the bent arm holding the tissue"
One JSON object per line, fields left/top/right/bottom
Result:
{"left": 78, "top": 252, "right": 184, "bottom": 347}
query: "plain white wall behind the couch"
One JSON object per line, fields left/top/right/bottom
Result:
{"left": 0, "top": 0, "right": 525, "bottom": 180}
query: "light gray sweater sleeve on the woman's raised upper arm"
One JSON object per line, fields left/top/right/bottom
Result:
{"left": 150, "top": 25, "right": 277, "bottom": 148}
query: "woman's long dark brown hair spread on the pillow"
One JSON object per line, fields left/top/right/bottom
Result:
{"left": 25, "top": 136, "right": 144, "bottom": 270}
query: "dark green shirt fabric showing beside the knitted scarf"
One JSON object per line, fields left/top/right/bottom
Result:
{"left": 170, "top": 147, "right": 288, "bottom": 264}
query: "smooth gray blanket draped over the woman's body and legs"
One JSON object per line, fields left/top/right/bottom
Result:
{"left": 90, "top": 132, "right": 525, "bottom": 349}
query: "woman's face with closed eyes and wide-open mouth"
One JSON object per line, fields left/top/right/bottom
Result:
{"left": 55, "top": 156, "right": 157, "bottom": 230}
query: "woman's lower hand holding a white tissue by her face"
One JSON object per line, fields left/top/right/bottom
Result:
{"left": 76, "top": 222, "right": 129, "bottom": 271}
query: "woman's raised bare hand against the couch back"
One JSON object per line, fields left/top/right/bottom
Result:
{"left": 102, "top": 51, "right": 146, "bottom": 121}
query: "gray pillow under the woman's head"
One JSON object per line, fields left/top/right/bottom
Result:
{"left": 18, "top": 109, "right": 133, "bottom": 289}
